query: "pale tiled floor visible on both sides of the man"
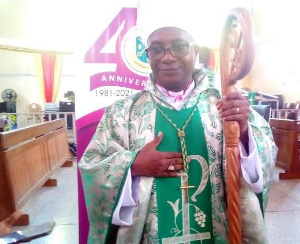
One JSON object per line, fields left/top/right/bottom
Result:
{"left": 9, "top": 163, "right": 300, "bottom": 244}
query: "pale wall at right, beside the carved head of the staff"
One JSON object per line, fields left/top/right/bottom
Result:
{"left": 251, "top": 41, "right": 300, "bottom": 102}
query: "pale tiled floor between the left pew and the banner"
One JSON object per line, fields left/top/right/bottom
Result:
{"left": 14, "top": 162, "right": 79, "bottom": 244}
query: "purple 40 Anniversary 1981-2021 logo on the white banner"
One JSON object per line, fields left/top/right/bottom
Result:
{"left": 84, "top": 8, "right": 150, "bottom": 106}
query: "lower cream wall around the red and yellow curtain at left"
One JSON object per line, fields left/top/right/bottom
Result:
{"left": 0, "top": 50, "right": 75, "bottom": 113}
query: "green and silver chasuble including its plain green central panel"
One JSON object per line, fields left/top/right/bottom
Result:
{"left": 78, "top": 70, "right": 277, "bottom": 244}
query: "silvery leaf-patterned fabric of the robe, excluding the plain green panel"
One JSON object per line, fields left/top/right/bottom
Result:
{"left": 79, "top": 70, "right": 277, "bottom": 243}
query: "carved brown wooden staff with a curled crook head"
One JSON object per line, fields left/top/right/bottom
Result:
{"left": 220, "top": 8, "right": 255, "bottom": 244}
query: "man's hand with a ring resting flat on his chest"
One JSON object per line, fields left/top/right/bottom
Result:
{"left": 131, "top": 132, "right": 183, "bottom": 177}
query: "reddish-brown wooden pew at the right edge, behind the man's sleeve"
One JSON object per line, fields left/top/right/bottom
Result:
{"left": 270, "top": 118, "right": 300, "bottom": 180}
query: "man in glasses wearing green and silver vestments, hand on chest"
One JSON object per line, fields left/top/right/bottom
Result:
{"left": 79, "top": 26, "right": 276, "bottom": 243}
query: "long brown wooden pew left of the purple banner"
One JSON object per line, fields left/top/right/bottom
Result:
{"left": 0, "top": 119, "right": 72, "bottom": 225}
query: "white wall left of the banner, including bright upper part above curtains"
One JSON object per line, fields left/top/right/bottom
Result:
{"left": 0, "top": 0, "right": 75, "bottom": 113}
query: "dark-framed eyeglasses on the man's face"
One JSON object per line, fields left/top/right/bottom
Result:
{"left": 145, "top": 42, "right": 194, "bottom": 60}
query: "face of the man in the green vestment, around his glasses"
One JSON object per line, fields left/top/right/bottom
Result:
{"left": 148, "top": 27, "right": 196, "bottom": 92}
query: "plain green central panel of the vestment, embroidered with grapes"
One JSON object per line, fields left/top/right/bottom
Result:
{"left": 154, "top": 105, "right": 213, "bottom": 244}
